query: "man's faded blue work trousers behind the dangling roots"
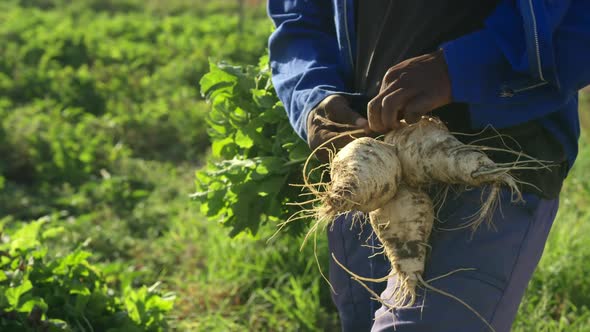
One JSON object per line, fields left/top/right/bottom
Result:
{"left": 328, "top": 190, "right": 558, "bottom": 332}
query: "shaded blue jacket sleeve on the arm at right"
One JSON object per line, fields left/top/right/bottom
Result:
{"left": 442, "top": 0, "right": 590, "bottom": 127}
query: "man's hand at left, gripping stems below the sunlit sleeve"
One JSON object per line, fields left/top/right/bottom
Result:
{"left": 307, "top": 95, "right": 369, "bottom": 162}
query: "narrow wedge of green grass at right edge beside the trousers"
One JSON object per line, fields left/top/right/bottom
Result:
{"left": 514, "top": 94, "right": 590, "bottom": 332}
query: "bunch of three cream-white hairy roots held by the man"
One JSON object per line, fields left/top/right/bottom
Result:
{"left": 303, "top": 117, "right": 546, "bottom": 328}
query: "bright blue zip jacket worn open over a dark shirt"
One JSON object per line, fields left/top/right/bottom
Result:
{"left": 268, "top": 0, "right": 590, "bottom": 166}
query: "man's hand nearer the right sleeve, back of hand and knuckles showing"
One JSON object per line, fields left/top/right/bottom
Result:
{"left": 367, "top": 50, "right": 451, "bottom": 133}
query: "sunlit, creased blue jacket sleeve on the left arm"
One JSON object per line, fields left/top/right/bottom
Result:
{"left": 268, "top": 0, "right": 356, "bottom": 140}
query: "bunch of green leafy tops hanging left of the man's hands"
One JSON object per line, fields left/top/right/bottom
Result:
{"left": 194, "top": 57, "right": 310, "bottom": 236}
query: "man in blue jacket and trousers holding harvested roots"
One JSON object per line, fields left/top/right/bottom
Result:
{"left": 268, "top": 0, "right": 590, "bottom": 332}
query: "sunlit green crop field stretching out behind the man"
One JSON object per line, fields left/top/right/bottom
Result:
{"left": 0, "top": 0, "right": 590, "bottom": 332}
